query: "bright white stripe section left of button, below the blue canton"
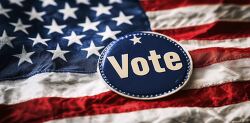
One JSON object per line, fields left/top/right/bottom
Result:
{"left": 0, "top": 72, "right": 108, "bottom": 104}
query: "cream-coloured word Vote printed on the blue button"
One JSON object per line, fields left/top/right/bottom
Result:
{"left": 107, "top": 50, "right": 182, "bottom": 79}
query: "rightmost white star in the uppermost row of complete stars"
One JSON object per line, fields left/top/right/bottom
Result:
{"left": 91, "top": 3, "right": 112, "bottom": 16}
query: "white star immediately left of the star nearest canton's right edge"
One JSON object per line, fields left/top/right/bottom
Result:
{"left": 79, "top": 17, "right": 101, "bottom": 31}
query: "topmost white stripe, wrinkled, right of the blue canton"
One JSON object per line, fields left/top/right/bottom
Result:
{"left": 146, "top": 4, "right": 250, "bottom": 30}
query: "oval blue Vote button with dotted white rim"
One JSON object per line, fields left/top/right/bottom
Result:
{"left": 98, "top": 32, "right": 193, "bottom": 99}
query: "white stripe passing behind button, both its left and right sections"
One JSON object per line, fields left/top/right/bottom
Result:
{"left": 0, "top": 59, "right": 250, "bottom": 104}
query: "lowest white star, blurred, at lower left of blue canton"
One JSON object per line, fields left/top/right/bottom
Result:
{"left": 13, "top": 46, "right": 35, "bottom": 66}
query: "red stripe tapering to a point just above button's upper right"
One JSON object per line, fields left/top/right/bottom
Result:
{"left": 155, "top": 21, "right": 250, "bottom": 40}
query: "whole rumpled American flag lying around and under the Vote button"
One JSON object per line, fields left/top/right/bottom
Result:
{"left": 0, "top": 0, "right": 250, "bottom": 123}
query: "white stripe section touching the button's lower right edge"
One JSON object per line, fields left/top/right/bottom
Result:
{"left": 185, "top": 58, "right": 250, "bottom": 89}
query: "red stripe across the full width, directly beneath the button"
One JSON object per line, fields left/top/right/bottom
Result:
{"left": 0, "top": 81, "right": 250, "bottom": 123}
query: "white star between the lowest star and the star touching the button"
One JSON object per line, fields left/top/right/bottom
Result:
{"left": 47, "top": 44, "right": 69, "bottom": 62}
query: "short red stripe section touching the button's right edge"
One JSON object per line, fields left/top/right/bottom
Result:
{"left": 190, "top": 48, "right": 250, "bottom": 68}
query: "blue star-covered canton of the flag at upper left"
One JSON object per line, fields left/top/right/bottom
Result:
{"left": 0, "top": 0, "right": 150, "bottom": 80}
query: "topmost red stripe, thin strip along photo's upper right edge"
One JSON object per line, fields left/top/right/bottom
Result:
{"left": 140, "top": 0, "right": 250, "bottom": 11}
